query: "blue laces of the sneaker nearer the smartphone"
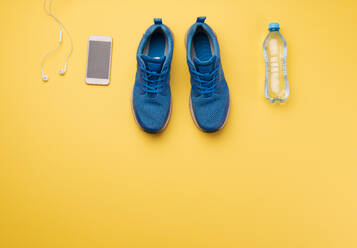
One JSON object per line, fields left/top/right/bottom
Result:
{"left": 139, "top": 66, "right": 168, "bottom": 94}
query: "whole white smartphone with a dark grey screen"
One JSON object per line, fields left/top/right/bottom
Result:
{"left": 86, "top": 35, "right": 113, "bottom": 85}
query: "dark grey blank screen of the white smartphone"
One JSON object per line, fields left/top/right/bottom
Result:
{"left": 87, "top": 40, "right": 112, "bottom": 79}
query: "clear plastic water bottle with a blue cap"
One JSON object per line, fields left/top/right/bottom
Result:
{"left": 263, "top": 23, "right": 290, "bottom": 103}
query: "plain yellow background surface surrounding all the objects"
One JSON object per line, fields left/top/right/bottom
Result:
{"left": 0, "top": 0, "right": 357, "bottom": 248}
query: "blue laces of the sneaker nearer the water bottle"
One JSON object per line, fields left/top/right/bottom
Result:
{"left": 190, "top": 66, "right": 219, "bottom": 94}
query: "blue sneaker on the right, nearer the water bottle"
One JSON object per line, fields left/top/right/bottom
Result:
{"left": 186, "top": 17, "right": 230, "bottom": 132}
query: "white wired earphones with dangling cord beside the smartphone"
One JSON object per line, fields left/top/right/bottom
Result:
{"left": 41, "top": 0, "right": 73, "bottom": 82}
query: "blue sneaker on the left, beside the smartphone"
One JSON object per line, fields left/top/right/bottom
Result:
{"left": 132, "top": 18, "right": 174, "bottom": 133}
